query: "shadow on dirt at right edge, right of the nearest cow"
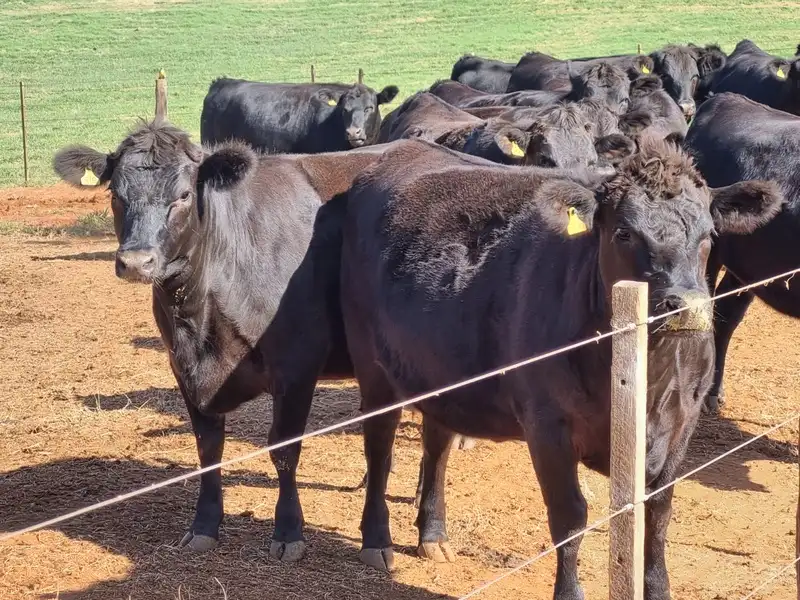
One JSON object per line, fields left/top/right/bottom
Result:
{"left": 682, "top": 415, "right": 797, "bottom": 493}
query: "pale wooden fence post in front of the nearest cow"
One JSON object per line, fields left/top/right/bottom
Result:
{"left": 608, "top": 281, "right": 647, "bottom": 600}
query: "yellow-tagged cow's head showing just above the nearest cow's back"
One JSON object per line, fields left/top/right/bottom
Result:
{"left": 464, "top": 104, "right": 634, "bottom": 170}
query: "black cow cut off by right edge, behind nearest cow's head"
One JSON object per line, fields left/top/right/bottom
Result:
{"left": 685, "top": 93, "right": 800, "bottom": 411}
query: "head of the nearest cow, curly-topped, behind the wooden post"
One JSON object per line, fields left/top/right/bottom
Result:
{"left": 538, "top": 140, "right": 784, "bottom": 327}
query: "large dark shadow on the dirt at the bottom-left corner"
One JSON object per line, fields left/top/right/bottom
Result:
{"left": 0, "top": 458, "right": 450, "bottom": 600}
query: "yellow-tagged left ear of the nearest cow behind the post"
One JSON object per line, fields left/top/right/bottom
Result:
{"left": 534, "top": 179, "right": 598, "bottom": 237}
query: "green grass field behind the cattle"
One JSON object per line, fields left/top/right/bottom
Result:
{"left": 0, "top": 0, "right": 800, "bottom": 186}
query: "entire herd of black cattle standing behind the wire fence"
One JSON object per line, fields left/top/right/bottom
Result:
{"left": 54, "top": 40, "right": 800, "bottom": 600}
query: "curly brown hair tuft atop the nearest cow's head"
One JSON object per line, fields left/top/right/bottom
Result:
{"left": 607, "top": 138, "right": 706, "bottom": 201}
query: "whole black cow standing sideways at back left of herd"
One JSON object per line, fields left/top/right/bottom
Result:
{"left": 200, "top": 78, "right": 398, "bottom": 154}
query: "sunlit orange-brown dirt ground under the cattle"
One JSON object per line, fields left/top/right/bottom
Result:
{"left": 0, "top": 187, "right": 800, "bottom": 600}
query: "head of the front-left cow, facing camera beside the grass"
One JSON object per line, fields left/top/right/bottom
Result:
{"left": 53, "top": 123, "right": 204, "bottom": 283}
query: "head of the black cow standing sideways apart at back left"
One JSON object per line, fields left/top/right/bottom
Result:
{"left": 324, "top": 84, "right": 399, "bottom": 148}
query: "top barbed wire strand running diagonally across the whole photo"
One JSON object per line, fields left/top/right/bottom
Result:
{"left": 0, "top": 267, "right": 800, "bottom": 542}
